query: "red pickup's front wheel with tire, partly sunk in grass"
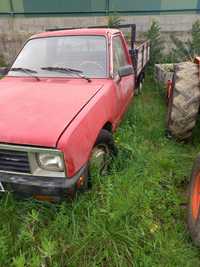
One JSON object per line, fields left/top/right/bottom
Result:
{"left": 88, "top": 129, "right": 117, "bottom": 182}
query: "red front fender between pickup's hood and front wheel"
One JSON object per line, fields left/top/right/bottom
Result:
{"left": 57, "top": 81, "right": 116, "bottom": 177}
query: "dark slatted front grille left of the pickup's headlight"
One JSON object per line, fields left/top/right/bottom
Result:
{"left": 0, "top": 149, "right": 30, "bottom": 173}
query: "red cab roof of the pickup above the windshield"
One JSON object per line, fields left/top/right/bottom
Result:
{"left": 30, "top": 28, "right": 119, "bottom": 39}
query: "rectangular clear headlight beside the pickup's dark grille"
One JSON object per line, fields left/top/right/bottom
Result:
{"left": 36, "top": 153, "right": 64, "bottom": 172}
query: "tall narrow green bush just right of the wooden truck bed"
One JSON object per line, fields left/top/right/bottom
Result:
{"left": 145, "top": 20, "right": 164, "bottom": 66}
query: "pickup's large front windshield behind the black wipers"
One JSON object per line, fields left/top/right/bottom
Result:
{"left": 9, "top": 36, "right": 107, "bottom": 78}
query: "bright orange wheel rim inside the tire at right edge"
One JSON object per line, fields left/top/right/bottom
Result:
{"left": 192, "top": 173, "right": 200, "bottom": 220}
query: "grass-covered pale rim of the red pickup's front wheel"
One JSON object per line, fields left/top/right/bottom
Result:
{"left": 89, "top": 145, "right": 110, "bottom": 175}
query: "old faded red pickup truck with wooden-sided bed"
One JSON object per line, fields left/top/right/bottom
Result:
{"left": 0, "top": 25, "right": 149, "bottom": 201}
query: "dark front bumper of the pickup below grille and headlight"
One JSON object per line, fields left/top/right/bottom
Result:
{"left": 0, "top": 166, "right": 86, "bottom": 197}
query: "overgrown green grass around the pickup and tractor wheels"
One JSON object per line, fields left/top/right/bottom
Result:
{"left": 0, "top": 74, "right": 200, "bottom": 267}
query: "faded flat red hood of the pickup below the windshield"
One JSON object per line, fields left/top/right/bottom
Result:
{"left": 0, "top": 77, "right": 102, "bottom": 147}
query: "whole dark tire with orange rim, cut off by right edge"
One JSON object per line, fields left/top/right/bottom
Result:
{"left": 188, "top": 155, "right": 200, "bottom": 246}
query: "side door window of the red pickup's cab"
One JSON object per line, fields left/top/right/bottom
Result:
{"left": 113, "top": 36, "right": 128, "bottom": 75}
